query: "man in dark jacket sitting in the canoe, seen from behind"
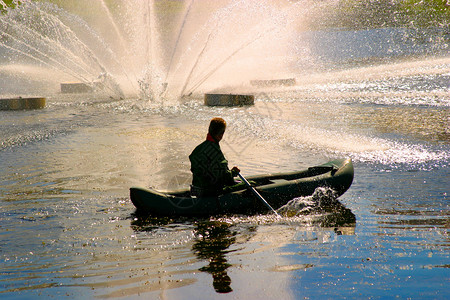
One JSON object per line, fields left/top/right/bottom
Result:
{"left": 189, "top": 118, "right": 240, "bottom": 197}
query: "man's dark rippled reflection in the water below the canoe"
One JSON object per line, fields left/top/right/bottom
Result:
{"left": 192, "top": 222, "right": 236, "bottom": 293}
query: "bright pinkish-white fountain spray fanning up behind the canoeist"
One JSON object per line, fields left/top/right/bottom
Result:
{"left": 0, "top": 0, "right": 308, "bottom": 100}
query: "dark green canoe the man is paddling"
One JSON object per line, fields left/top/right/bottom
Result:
{"left": 130, "top": 159, "right": 353, "bottom": 217}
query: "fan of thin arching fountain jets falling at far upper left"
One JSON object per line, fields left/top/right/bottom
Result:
{"left": 0, "top": 1, "right": 126, "bottom": 94}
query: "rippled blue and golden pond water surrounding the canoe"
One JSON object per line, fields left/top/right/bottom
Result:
{"left": 0, "top": 59, "right": 450, "bottom": 299}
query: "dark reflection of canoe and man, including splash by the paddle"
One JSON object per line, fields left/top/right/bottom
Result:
{"left": 131, "top": 191, "right": 356, "bottom": 293}
